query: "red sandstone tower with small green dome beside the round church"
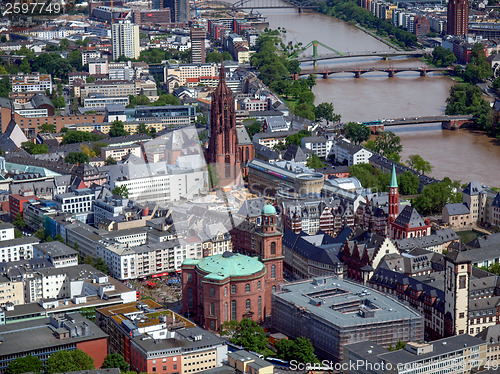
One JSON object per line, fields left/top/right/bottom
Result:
{"left": 255, "top": 205, "right": 283, "bottom": 316}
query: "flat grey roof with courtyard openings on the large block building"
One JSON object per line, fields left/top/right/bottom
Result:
{"left": 275, "top": 277, "right": 423, "bottom": 327}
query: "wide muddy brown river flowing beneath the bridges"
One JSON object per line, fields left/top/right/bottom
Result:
{"left": 231, "top": 0, "right": 500, "bottom": 186}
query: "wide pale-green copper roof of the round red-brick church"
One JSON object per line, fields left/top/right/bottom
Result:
{"left": 197, "top": 252, "right": 264, "bottom": 280}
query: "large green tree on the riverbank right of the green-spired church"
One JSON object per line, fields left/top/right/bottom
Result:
{"left": 412, "top": 178, "right": 462, "bottom": 214}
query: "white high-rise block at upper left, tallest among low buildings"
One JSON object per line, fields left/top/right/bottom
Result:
{"left": 111, "top": 21, "right": 141, "bottom": 60}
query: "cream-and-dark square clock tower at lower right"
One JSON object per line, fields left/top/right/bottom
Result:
{"left": 444, "top": 251, "right": 471, "bottom": 337}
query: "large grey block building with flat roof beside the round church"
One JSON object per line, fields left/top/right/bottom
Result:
{"left": 272, "top": 277, "right": 424, "bottom": 362}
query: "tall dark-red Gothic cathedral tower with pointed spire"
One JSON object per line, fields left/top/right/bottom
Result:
{"left": 207, "top": 61, "right": 240, "bottom": 165}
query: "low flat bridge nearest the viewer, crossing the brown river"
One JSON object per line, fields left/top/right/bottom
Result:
{"left": 363, "top": 115, "right": 474, "bottom": 134}
